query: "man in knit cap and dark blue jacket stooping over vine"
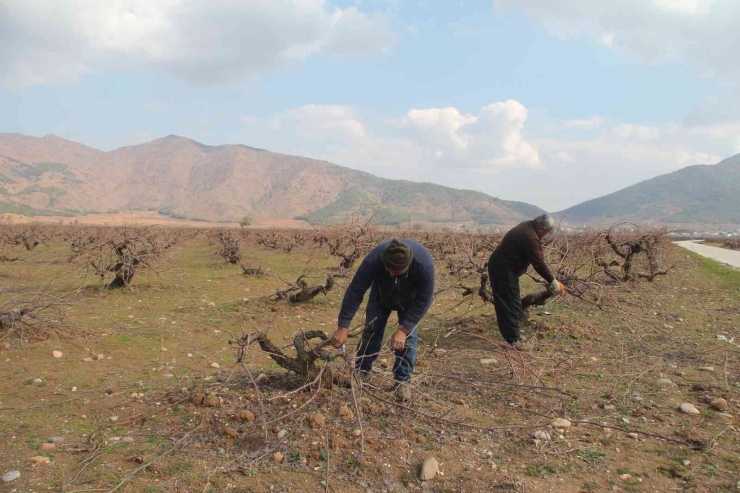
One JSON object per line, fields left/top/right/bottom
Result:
{"left": 332, "top": 239, "right": 434, "bottom": 400}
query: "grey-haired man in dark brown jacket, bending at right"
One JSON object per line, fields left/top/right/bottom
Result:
{"left": 488, "top": 214, "right": 565, "bottom": 350}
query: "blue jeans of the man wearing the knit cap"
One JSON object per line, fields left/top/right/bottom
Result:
{"left": 355, "top": 293, "right": 418, "bottom": 382}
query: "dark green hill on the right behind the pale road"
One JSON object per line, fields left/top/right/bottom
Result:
{"left": 556, "top": 154, "right": 740, "bottom": 225}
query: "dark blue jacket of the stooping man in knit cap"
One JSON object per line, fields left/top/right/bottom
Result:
{"left": 338, "top": 239, "right": 434, "bottom": 330}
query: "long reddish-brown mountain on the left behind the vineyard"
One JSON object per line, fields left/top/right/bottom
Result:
{"left": 0, "top": 134, "right": 542, "bottom": 225}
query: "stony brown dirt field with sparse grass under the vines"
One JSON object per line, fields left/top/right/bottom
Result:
{"left": 0, "top": 231, "right": 740, "bottom": 493}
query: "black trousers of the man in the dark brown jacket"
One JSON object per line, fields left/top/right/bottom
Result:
{"left": 488, "top": 262, "right": 522, "bottom": 343}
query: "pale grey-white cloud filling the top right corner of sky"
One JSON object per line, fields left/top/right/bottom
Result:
{"left": 493, "top": 0, "right": 740, "bottom": 83}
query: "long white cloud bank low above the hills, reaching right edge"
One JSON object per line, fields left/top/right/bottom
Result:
{"left": 270, "top": 100, "right": 740, "bottom": 211}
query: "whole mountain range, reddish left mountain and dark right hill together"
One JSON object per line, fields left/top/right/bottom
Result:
{"left": 0, "top": 133, "right": 740, "bottom": 226}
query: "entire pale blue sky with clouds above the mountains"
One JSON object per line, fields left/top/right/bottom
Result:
{"left": 0, "top": 0, "right": 740, "bottom": 210}
